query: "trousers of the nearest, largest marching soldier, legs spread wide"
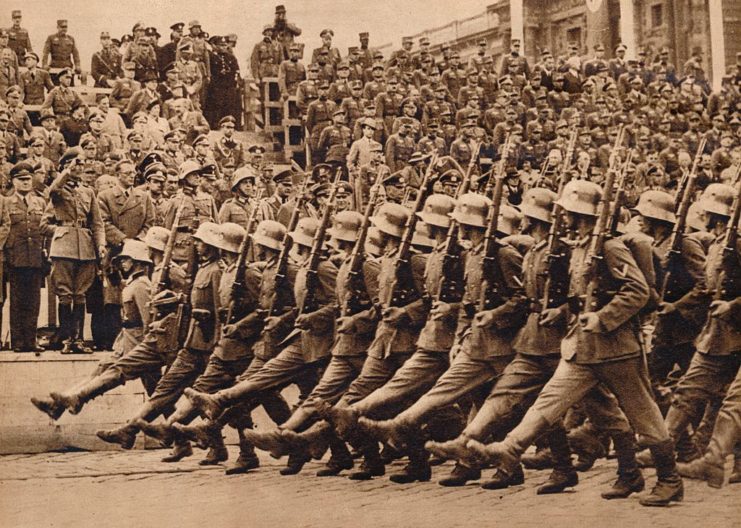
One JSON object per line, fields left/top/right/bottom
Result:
{"left": 528, "top": 357, "right": 669, "bottom": 446}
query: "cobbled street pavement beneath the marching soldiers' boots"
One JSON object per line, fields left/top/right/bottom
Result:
{"left": 0, "top": 447, "right": 741, "bottom": 528}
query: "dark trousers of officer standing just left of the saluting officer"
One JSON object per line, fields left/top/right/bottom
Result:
{"left": 6, "top": 266, "right": 44, "bottom": 349}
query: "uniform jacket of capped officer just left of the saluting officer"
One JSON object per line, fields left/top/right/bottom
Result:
{"left": 0, "top": 193, "right": 46, "bottom": 268}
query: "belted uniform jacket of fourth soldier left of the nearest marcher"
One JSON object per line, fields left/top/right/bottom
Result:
{"left": 368, "top": 249, "right": 427, "bottom": 359}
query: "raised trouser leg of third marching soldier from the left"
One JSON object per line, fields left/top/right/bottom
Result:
{"left": 143, "top": 348, "right": 210, "bottom": 421}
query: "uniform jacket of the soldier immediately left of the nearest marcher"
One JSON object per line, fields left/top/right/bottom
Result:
{"left": 512, "top": 240, "right": 568, "bottom": 356}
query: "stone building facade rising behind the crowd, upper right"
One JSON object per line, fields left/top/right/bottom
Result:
{"left": 413, "top": 0, "right": 741, "bottom": 86}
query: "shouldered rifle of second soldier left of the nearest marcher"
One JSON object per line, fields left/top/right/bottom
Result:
{"left": 478, "top": 135, "right": 512, "bottom": 312}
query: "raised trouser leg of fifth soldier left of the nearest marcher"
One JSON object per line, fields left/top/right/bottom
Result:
{"left": 282, "top": 356, "right": 366, "bottom": 431}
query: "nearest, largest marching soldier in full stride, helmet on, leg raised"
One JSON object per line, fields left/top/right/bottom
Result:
{"left": 467, "top": 180, "right": 683, "bottom": 506}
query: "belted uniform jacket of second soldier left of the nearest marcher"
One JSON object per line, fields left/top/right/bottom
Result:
{"left": 456, "top": 242, "right": 524, "bottom": 360}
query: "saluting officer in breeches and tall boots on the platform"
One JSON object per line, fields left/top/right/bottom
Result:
{"left": 41, "top": 149, "right": 106, "bottom": 354}
